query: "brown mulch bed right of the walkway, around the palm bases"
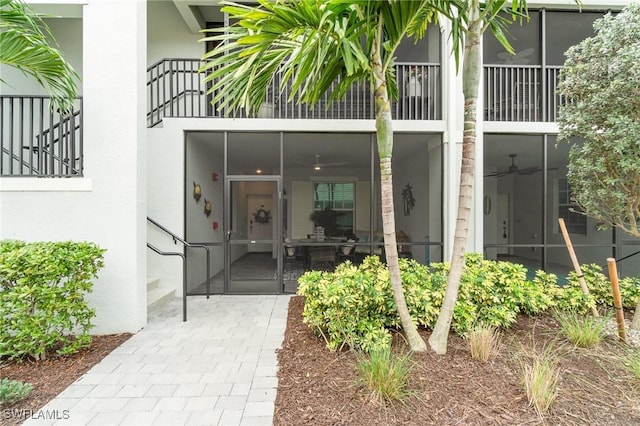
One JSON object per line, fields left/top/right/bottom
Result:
{"left": 274, "top": 296, "right": 640, "bottom": 426}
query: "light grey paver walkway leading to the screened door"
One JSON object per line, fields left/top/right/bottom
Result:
{"left": 24, "top": 295, "right": 290, "bottom": 425}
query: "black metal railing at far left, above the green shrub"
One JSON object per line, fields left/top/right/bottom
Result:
{"left": 0, "top": 96, "right": 83, "bottom": 177}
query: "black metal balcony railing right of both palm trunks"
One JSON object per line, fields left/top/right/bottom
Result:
{"left": 483, "top": 65, "right": 562, "bottom": 122}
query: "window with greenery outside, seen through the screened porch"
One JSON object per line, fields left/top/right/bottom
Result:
{"left": 313, "top": 182, "right": 355, "bottom": 237}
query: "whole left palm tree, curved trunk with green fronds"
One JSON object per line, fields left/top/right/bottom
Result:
{"left": 201, "top": 0, "right": 437, "bottom": 351}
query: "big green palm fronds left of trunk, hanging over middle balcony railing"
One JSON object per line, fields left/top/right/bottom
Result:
{"left": 201, "top": 0, "right": 368, "bottom": 114}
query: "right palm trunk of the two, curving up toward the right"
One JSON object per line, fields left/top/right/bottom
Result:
{"left": 429, "top": 8, "right": 482, "bottom": 355}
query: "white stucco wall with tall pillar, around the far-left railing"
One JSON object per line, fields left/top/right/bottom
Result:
{"left": 0, "top": 0, "right": 146, "bottom": 334}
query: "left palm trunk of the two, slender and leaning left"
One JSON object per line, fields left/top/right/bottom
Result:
{"left": 372, "top": 28, "right": 427, "bottom": 352}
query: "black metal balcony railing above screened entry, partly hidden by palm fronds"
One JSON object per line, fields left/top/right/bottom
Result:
{"left": 147, "top": 59, "right": 442, "bottom": 127}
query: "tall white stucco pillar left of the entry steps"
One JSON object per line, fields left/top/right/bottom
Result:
{"left": 78, "top": 0, "right": 147, "bottom": 332}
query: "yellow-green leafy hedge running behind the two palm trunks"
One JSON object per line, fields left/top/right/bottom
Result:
{"left": 298, "top": 254, "right": 640, "bottom": 351}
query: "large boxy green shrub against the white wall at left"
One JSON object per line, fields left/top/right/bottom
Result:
{"left": 0, "top": 241, "right": 104, "bottom": 359}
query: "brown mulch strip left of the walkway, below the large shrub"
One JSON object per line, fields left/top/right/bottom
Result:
{"left": 0, "top": 333, "right": 132, "bottom": 425}
